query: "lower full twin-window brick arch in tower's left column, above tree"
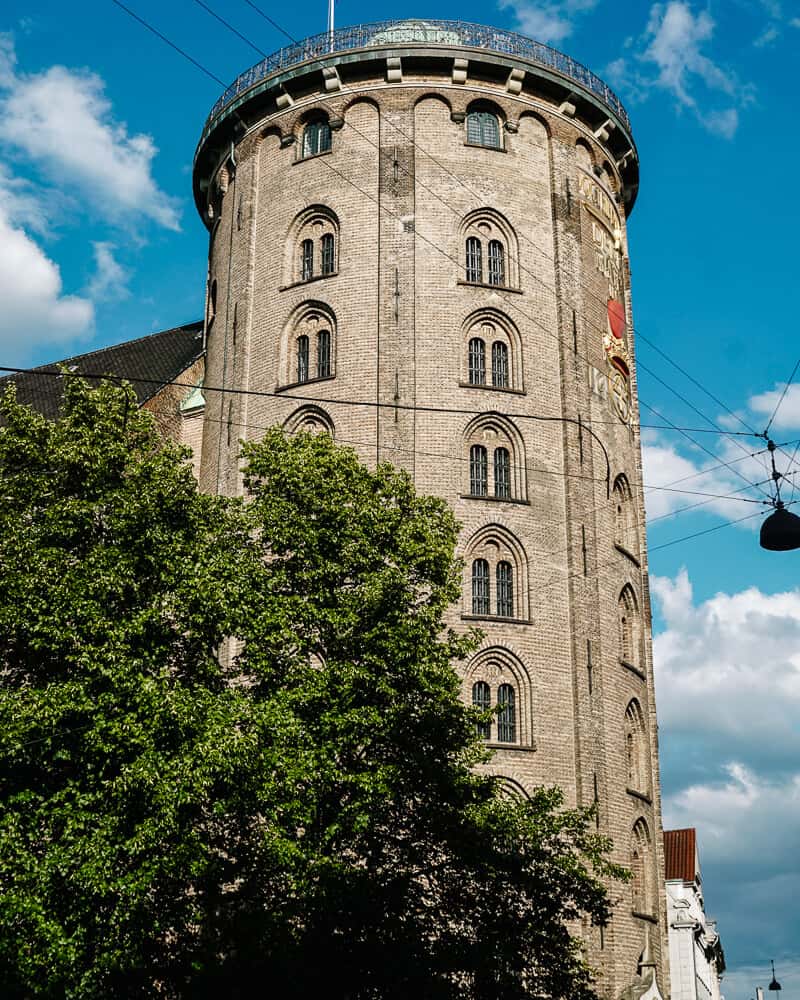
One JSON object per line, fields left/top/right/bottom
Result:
{"left": 279, "top": 302, "right": 336, "bottom": 388}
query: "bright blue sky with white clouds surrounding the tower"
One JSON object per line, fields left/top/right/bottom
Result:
{"left": 0, "top": 0, "right": 800, "bottom": 1000}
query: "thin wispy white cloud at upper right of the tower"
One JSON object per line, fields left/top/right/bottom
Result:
{"left": 606, "top": 0, "right": 752, "bottom": 138}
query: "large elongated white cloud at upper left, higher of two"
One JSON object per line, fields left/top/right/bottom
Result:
{"left": 0, "top": 35, "right": 179, "bottom": 229}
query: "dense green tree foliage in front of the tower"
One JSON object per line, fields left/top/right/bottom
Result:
{"left": 0, "top": 380, "right": 621, "bottom": 1000}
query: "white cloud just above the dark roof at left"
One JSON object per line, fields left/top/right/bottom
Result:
{"left": 0, "top": 199, "right": 94, "bottom": 364}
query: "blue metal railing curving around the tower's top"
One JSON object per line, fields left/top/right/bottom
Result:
{"left": 203, "top": 20, "right": 630, "bottom": 135}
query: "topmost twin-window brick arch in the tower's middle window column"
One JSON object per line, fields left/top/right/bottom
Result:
{"left": 459, "top": 207, "right": 519, "bottom": 288}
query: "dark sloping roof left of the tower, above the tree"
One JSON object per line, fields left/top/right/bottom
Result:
{"left": 0, "top": 322, "right": 203, "bottom": 419}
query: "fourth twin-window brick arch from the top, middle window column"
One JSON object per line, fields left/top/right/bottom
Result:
{"left": 464, "top": 524, "right": 529, "bottom": 620}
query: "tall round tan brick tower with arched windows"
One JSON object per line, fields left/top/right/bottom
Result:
{"left": 194, "top": 21, "right": 669, "bottom": 1000}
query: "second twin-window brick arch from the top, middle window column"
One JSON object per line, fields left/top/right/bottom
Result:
{"left": 461, "top": 309, "right": 523, "bottom": 392}
